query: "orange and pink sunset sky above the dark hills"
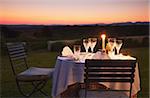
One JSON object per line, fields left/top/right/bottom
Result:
{"left": 0, "top": 0, "right": 149, "bottom": 24}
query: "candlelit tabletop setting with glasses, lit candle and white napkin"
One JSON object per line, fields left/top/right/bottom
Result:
{"left": 58, "top": 34, "right": 136, "bottom": 63}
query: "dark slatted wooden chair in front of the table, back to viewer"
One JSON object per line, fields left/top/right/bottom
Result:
{"left": 84, "top": 59, "right": 136, "bottom": 98}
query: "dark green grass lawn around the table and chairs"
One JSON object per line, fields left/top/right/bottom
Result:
{"left": 0, "top": 48, "right": 149, "bottom": 98}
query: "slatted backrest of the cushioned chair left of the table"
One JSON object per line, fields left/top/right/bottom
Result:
{"left": 6, "top": 42, "right": 28, "bottom": 75}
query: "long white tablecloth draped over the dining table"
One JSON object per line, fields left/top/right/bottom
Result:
{"left": 52, "top": 55, "right": 140, "bottom": 98}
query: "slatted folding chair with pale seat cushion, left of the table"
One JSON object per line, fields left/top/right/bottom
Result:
{"left": 6, "top": 42, "right": 54, "bottom": 97}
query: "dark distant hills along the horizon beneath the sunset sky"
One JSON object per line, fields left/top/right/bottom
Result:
{"left": 0, "top": 22, "right": 149, "bottom": 40}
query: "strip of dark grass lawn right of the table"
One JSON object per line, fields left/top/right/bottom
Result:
{"left": 124, "top": 48, "right": 149, "bottom": 98}
